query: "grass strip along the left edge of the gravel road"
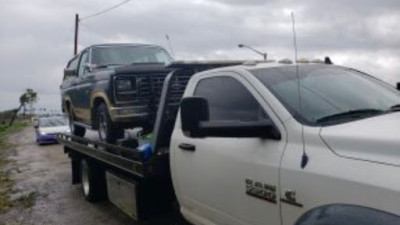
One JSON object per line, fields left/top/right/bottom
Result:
{"left": 0, "top": 120, "right": 29, "bottom": 214}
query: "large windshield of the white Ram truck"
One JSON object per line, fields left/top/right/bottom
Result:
{"left": 255, "top": 65, "right": 400, "bottom": 125}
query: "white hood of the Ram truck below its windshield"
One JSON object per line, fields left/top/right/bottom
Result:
{"left": 321, "top": 112, "right": 400, "bottom": 166}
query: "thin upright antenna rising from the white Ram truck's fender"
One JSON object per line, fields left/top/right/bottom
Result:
{"left": 292, "top": 12, "right": 309, "bottom": 169}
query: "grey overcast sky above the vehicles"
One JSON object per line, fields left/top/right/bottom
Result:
{"left": 0, "top": 0, "right": 400, "bottom": 110}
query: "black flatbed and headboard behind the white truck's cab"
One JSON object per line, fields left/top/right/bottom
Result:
{"left": 57, "top": 61, "right": 244, "bottom": 220}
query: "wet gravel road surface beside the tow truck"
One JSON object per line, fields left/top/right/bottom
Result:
{"left": 0, "top": 127, "right": 186, "bottom": 225}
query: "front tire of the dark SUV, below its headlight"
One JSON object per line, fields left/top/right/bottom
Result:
{"left": 96, "top": 103, "right": 124, "bottom": 144}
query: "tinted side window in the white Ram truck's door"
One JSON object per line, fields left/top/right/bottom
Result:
{"left": 194, "top": 77, "right": 268, "bottom": 121}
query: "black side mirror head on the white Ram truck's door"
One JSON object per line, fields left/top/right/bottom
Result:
{"left": 181, "top": 97, "right": 209, "bottom": 137}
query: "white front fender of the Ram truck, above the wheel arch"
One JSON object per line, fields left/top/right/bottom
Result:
{"left": 280, "top": 119, "right": 400, "bottom": 225}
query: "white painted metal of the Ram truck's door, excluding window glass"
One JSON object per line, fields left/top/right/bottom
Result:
{"left": 171, "top": 73, "right": 286, "bottom": 225}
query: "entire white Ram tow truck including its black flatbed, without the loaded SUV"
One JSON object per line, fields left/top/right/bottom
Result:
{"left": 58, "top": 59, "right": 400, "bottom": 225}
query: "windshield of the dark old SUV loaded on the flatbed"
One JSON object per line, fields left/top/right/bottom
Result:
{"left": 91, "top": 46, "right": 172, "bottom": 65}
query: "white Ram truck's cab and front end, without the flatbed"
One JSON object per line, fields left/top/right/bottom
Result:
{"left": 170, "top": 64, "right": 400, "bottom": 225}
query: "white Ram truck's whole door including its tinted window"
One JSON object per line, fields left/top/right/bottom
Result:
{"left": 171, "top": 73, "right": 286, "bottom": 225}
